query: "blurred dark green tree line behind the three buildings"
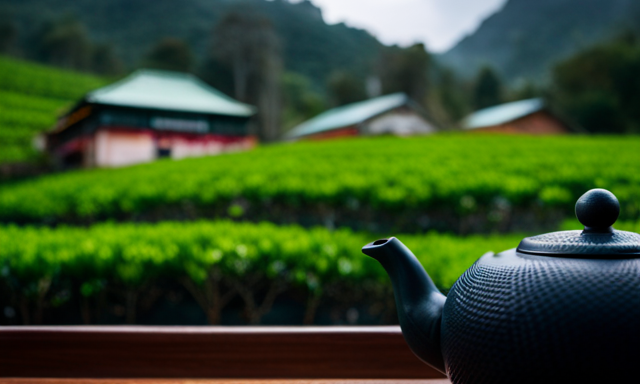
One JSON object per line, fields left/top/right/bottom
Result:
{"left": 0, "top": 9, "right": 640, "bottom": 141}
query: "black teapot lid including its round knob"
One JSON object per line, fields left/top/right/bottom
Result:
{"left": 516, "top": 189, "right": 640, "bottom": 259}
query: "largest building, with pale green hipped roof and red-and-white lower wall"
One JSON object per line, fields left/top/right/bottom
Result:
{"left": 47, "top": 70, "right": 255, "bottom": 168}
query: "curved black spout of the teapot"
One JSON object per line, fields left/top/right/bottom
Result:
{"left": 362, "top": 237, "right": 446, "bottom": 373}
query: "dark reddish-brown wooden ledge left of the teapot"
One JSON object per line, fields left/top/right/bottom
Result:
{"left": 0, "top": 326, "right": 444, "bottom": 383}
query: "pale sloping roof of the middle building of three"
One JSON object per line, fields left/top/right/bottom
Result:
{"left": 286, "top": 93, "right": 409, "bottom": 139}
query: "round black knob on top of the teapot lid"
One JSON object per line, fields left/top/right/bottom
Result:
{"left": 576, "top": 188, "right": 620, "bottom": 233}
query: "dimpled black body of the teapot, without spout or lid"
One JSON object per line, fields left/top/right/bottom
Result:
{"left": 441, "top": 251, "right": 640, "bottom": 384}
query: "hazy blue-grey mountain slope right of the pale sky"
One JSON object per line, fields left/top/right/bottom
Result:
{"left": 440, "top": 0, "right": 640, "bottom": 81}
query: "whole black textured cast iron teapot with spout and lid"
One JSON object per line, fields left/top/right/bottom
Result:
{"left": 362, "top": 189, "right": 640, "bottom": 384}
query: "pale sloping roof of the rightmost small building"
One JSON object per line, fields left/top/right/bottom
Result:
{"left": 462, "top": 99, "right": 544, "bottom": 129}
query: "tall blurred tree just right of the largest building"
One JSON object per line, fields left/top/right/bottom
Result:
{"left": 212, "top": 11, "right": 282, "bottom": 141}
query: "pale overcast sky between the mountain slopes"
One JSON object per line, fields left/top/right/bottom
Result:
{"left": 302, "top": 0, "right": 506, "bottom": 52}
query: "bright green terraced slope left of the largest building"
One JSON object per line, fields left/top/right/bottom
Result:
{"left": 0, "top": 56, "right": 107, "bottom": 163}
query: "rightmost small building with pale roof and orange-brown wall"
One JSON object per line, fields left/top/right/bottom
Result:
{"left": 462, "top": 98, "right": 571, "bottom": 135}
